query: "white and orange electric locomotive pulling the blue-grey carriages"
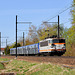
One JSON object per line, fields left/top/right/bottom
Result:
{"left": 39, "top": 38, "right": 66, "bottom": 55}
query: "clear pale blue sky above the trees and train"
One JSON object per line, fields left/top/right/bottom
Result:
{"left": 0, "top": 0, "right": 72, "bottom": 47}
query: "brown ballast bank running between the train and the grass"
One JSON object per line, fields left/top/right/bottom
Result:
{"left": 1, "top": 56, "right": 75, "bottom": 67}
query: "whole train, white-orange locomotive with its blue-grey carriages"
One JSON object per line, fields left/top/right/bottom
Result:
{"left": 10, "top": 38, "right": 66, "bottom": 56}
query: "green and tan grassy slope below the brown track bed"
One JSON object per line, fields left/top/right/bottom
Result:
{"left": 0, "top": 58, "right": 75, "bottom": 75}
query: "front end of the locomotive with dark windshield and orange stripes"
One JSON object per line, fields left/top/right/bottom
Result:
{"left": 49, "top": 38, "right": 66, "bottom": 55}
